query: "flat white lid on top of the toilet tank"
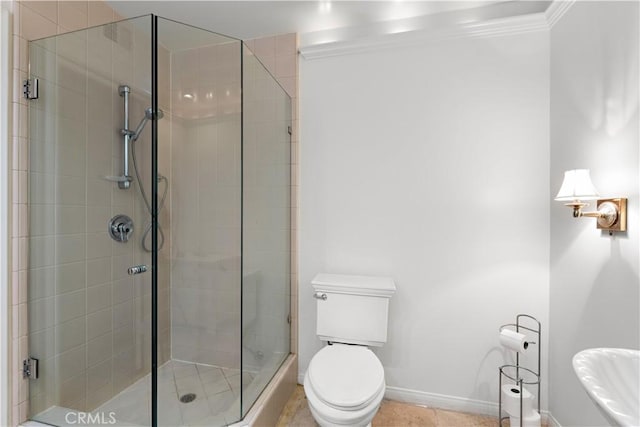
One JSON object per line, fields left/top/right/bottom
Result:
{"left": 311, "top": 273, "right": 396, "bottom": 297}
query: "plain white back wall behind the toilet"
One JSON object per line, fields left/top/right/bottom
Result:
{"left": 299, "top": 31, "right": 550, "bottom": 412}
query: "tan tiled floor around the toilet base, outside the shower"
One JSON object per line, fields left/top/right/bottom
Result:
{"left": 277, "top": 385, "right": 545, "bottom": 427}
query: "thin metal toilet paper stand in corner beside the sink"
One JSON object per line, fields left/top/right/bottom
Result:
{"left": 498, "top": 314, "right": 542, "bottom": 427}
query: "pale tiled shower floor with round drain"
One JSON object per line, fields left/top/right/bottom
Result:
{"left": 32, "top": 355, "right": 272, "bottom": 427}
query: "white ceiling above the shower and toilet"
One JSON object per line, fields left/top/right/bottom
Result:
{"left": 107, "top": 0, "right": 550, "bottom": 40}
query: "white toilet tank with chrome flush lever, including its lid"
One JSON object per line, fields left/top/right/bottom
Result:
{"left": 311, "top": 273, "right": 396, "bottom": 346}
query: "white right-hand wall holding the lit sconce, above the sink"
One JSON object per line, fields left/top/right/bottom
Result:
{"left": 549, "top": 2, "right": 640, "bottom": 426}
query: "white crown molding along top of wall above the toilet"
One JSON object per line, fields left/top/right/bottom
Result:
{"left": 299, "top": 12, "right": 555, "bottom": 60}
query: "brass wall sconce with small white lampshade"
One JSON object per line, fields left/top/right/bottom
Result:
{"left": 555, "top": 169, "right": 627, "bottom": 234}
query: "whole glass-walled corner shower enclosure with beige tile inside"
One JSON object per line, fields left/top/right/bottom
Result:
{"left": 28, "top": 15, "right": 291, "bottom": 426}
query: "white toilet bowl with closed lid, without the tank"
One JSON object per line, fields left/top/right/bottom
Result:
{"left": 304, "top": 344, "right": 385, "bottom": 427}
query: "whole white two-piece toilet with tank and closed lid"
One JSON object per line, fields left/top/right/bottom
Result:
{"left": 304, "top": 274, "right": 396, "bottom": 427}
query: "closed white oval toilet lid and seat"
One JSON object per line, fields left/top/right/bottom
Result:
{"left": 306, "top": 344, "right": 385, "bottom": 411}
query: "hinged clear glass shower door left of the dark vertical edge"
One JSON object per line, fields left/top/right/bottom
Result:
{"left": 28, "top": 17, "right": 156, "bottom": 425}
